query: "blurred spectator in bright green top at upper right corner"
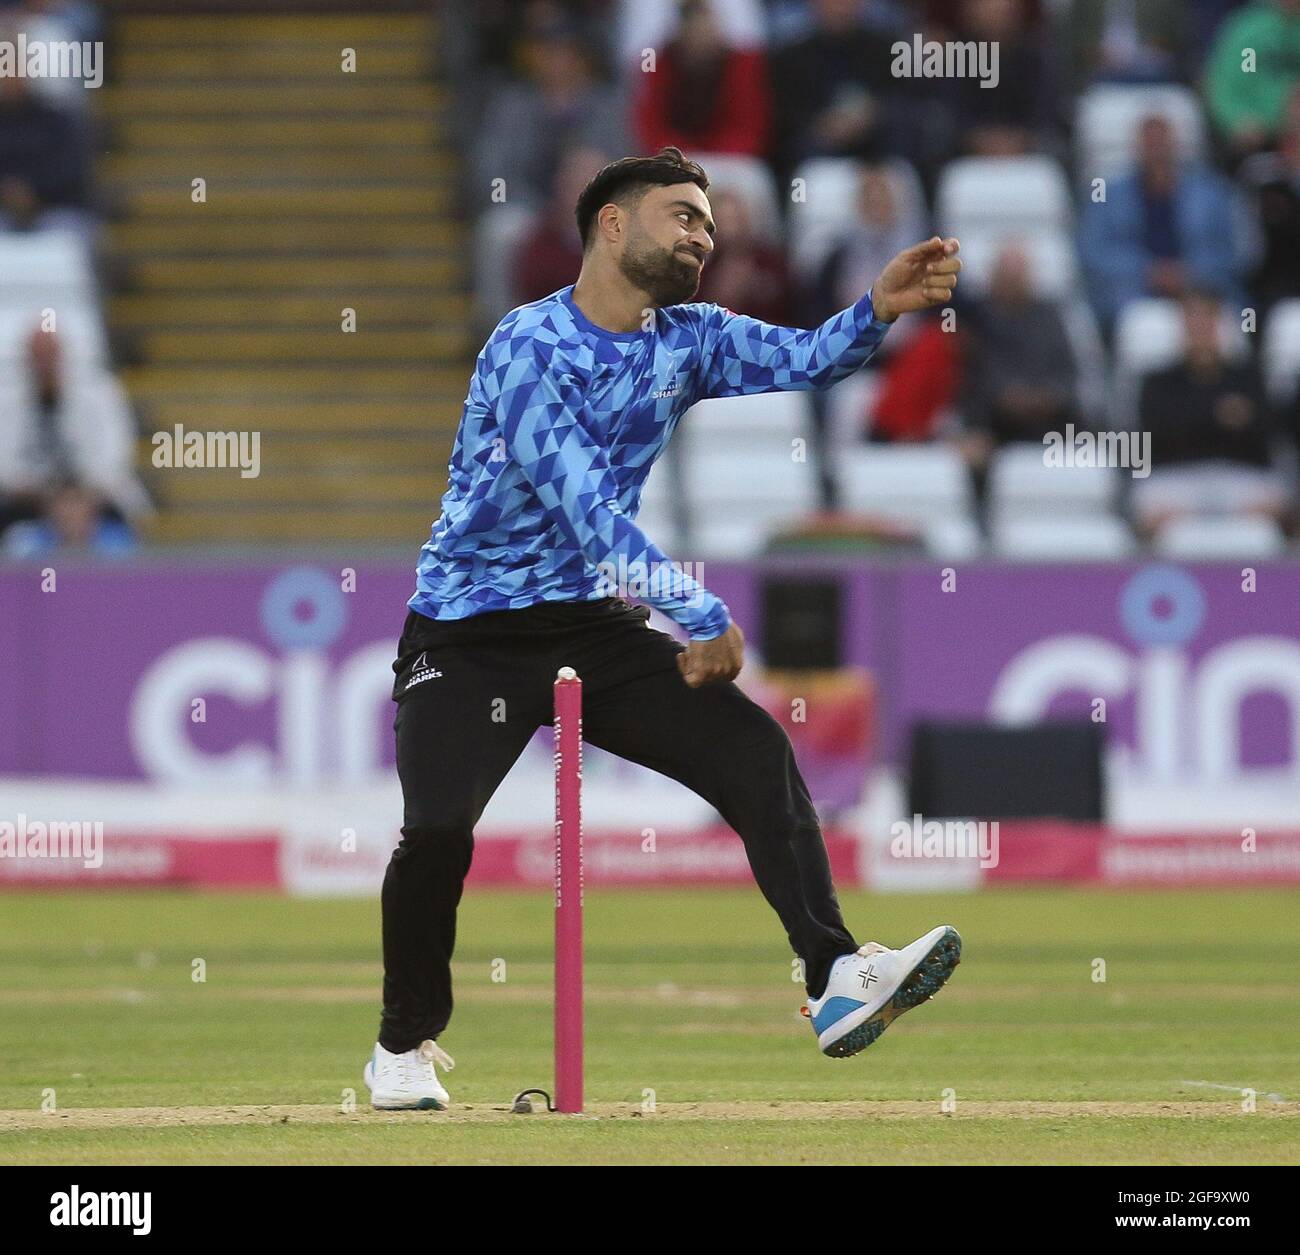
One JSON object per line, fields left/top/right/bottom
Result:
{"left": 1205, "top": 0, "right": 1300, "bottom": 159}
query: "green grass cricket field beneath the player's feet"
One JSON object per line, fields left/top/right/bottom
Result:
{"left": 0, "top": 890, "right": 1300, "bottom": 1164}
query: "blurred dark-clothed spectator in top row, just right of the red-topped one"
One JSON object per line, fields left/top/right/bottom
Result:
{"left": 771, "top": 0, "right": 904, "bottom": 177}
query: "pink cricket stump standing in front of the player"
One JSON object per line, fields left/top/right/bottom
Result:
{"left": 555, "top": 667, "right": 582, "bottom": 1112}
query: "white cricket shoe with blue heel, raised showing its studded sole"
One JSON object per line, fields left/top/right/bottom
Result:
{"left": 803, "top": 923, "right": 962, "bottom": 1059}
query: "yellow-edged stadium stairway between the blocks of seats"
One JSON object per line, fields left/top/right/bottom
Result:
{"left": 101, "top": 0, "right": 469, "bottom": 545}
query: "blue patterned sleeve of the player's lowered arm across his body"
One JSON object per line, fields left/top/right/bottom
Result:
{"left": 495, "top": 347, "right": 731, "bottom": 640}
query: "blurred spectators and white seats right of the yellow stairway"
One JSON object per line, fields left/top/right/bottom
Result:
{"left": 455, "top": 0, "right": 1300, "bottom": 557}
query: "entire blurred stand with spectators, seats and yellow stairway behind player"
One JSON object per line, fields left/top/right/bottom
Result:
{"left": 0, "top": 0, "right": 1300, "bottom": 559}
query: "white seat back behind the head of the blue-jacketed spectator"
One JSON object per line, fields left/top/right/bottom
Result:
{"left": 1075, "top": 85, "right": 1205, "bottom": 179}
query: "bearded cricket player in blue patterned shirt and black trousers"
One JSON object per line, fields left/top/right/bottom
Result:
{"left": 365, "top": 148, "right": 961, "bottom": 1109}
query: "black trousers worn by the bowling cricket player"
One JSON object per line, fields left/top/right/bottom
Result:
{"left": 380, "top": 598, "right": 857, "bottom": 1051}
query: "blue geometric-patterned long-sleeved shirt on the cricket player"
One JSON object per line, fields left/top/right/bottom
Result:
{"left": 408, "top": 286, "right": 889, "bottom": 640}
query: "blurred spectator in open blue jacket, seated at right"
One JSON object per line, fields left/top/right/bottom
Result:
{"left": 1079, "top": 114, "right": 1248, "bottom": 330}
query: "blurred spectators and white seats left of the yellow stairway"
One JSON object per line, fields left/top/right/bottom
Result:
{"left": 0, "top": 0, "right": 138, "bottom": 557}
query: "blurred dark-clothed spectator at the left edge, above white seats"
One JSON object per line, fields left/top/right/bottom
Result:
{"left": 0, "top": 69, "right": 88, "bottom": 230}
